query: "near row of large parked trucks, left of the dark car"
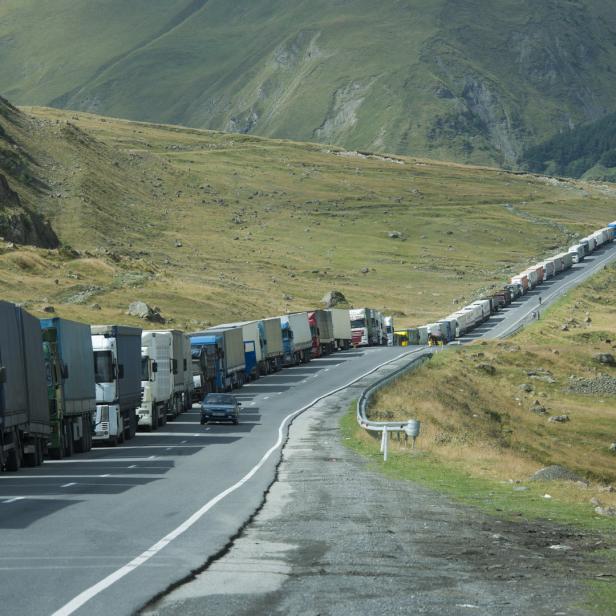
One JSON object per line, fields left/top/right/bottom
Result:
{"left": 0, "top": 301, "right": 393, "bottom": 471}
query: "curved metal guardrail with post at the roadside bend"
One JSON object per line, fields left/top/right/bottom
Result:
{"left": 357, "top": 348, "right": 433, "bottom": 462}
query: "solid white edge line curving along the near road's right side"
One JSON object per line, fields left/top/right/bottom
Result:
{"left": 52, "top": 351, "right": 417, "bottom": 616}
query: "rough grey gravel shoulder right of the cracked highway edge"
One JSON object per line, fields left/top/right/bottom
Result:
{"left": 142, "top": 361, "right": 596, "bottom": 616}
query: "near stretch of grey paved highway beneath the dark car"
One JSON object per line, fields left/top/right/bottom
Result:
{"left": 0, "top": 348, "right": 414, "bottom": 615}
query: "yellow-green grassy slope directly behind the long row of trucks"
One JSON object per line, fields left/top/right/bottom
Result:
{"left": 0, "top": 101, "right": 615, "bottom": 329}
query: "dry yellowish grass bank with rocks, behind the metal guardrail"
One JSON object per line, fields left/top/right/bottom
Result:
{"left": 358, "top": 266, "right": 616, "bottom": 516}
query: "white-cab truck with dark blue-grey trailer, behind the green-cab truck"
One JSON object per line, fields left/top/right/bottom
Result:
{"left": 90, "top": 325, "right": 141, "bottom": 445}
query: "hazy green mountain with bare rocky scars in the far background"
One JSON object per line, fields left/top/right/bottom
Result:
{"left": 0, "top": 0, "right": 616, "bottom": 165}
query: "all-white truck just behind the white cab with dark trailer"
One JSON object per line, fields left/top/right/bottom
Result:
{"left": 137, "top": 331, "right": 173, "bottom": 430}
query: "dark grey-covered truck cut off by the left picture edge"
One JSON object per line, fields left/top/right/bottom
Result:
{"left": 0, "top": 301, "right": 51, "bottom": 471}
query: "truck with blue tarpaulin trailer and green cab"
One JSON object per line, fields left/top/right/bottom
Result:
{"left": 40, "top": 317, "right": 96, "bottom": 458}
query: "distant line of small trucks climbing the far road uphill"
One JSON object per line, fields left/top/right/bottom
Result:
{"left": 394, "top": 221, "right": 616, "bottom": 346}
